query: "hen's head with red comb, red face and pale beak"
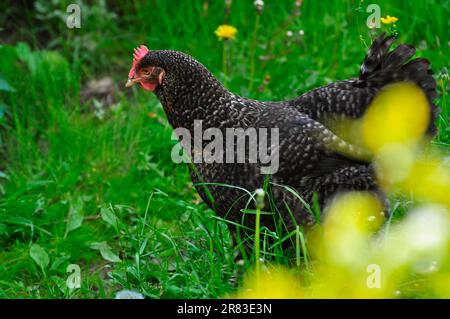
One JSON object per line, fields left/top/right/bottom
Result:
{"left": 125, "top": 45, "right": 165, "bottom": 92}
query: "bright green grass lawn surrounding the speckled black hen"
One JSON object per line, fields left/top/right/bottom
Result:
{"left": 0, "top": 0, "right": 450, "bottom": 298}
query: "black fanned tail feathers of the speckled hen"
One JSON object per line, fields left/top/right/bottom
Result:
{"left": 359, "top": 33, "right": 439, "bottom": 136}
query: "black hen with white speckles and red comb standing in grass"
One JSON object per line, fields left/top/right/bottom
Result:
{"left": 126, "top": 34, "right": 438, "bottom": 230}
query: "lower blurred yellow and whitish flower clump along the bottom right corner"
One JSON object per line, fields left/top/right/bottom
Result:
{"left": 231, "top": 192, "right": 450, "bottom": 299}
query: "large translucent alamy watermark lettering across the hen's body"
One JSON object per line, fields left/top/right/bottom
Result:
{"left": 171, "top": 120, "right": 279, "bottom": 174}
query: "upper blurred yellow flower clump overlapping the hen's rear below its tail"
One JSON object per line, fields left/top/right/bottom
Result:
{"left": 350, "top": 82, "right": 450, "bottom": 207}
